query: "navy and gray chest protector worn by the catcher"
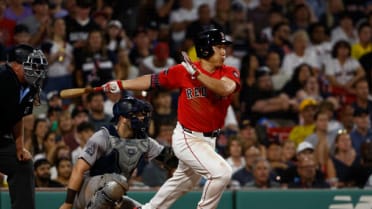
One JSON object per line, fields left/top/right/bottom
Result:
{"left": 90, "top": 127, "right": 149, "bottom": 179}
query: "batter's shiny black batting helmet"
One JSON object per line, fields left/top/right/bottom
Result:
{"left": 195, "top": 29, "right": 232, "bottom": 58}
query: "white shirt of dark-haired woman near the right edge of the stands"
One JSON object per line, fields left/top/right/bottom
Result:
{"left": 325, "top": 57, "right": 360, "bottom": 84}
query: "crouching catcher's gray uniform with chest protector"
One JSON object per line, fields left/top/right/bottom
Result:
{"left": 74, "top": 126, "right": 164, "bottom": 209}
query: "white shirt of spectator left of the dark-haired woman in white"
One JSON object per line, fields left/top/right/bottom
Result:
{"left": 281, "top": 48, "right": 320, "bottom": 77}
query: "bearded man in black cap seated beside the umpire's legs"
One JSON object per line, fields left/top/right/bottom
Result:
{"left": 34, "top": 158, "right": 63, "bottom": 187}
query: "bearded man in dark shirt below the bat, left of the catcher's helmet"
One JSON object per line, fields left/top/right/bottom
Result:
{"left": 87, "top": 93, "right": 111, "bottom": 131}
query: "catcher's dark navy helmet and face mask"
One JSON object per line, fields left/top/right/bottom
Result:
{"left": 112, "top": 96, "right": 152, "bottom": 138}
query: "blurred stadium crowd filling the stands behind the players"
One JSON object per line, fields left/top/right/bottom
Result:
{"left": 0, "top": 0, "right": 372, "bottom": 189}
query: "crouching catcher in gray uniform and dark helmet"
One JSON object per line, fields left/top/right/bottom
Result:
{"left": 60, "top": 97, "right": 178, "bottom": 209}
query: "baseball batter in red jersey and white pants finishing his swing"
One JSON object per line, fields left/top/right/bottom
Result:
{"left": 103, "top": 29, "right": 240, "bottom": 209}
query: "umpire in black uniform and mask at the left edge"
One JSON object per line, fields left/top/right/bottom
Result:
{"left": 0, "top": 44, "right": 47, "bottom": 209}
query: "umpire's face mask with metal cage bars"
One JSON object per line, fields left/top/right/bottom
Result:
{"left": 23, "top": 49, "right": 48, "bottom": 87}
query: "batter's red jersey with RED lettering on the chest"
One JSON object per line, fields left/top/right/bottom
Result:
{"left": 158, "top": 62, "right": 240, "bottom": 132}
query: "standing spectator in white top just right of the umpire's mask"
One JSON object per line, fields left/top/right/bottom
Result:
{"left": 43, "top": 18, "right": 74, "bottom": 93}
